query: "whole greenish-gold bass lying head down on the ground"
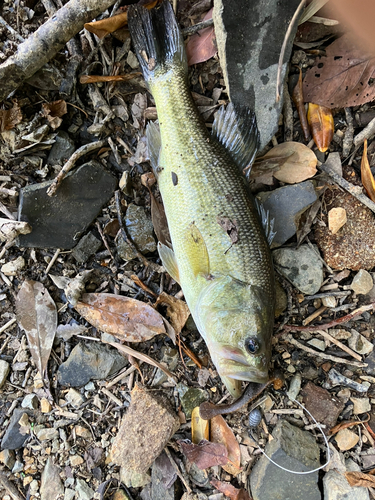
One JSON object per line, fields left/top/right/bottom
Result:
{"left": 128, "top": 0, "right": 275, "bottom": 397}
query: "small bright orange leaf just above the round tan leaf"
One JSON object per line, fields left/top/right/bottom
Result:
{"left": 307, "top": 102, "right": 335, "bottom": 153}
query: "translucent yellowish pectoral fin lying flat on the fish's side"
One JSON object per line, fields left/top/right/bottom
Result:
{"left": 185, "top": 222, "right": 210, "bottom": 277}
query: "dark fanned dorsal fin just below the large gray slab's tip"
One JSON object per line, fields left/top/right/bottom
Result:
{"left": 212, "top": 103, "right": 259, "bottom": 178}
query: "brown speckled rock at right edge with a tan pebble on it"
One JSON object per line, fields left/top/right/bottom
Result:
{"left": 315, "top": 186, "right": 375, "bottom": 271}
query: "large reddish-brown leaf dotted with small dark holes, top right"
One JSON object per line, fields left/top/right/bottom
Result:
{"left": 303, "top": 34, "right": 375, "bottom": 108}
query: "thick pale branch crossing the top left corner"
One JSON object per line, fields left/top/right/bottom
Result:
{"left": 0, "top": 0, "right": 115, "bottom": 101}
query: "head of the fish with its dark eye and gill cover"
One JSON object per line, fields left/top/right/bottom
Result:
{"left": 194, "top": 277, "right": 274, "bottom": 396}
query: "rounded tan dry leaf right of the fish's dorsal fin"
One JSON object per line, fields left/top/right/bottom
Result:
{"left": 262, "top": 141, "right": 318, "bottom": 184}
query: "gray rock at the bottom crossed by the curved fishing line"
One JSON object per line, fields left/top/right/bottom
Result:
{"left": 250, "top": 420, "right": 321, "bottom": 500}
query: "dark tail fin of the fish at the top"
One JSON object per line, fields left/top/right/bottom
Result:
{"left": 128, "top": 0, "right": 187, "bottom": 82}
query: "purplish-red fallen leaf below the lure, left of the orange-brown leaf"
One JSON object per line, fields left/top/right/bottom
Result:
{"left": 177, "top": 439, "right": 228, "bottom": 469}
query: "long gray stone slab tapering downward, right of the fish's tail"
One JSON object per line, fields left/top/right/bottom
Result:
{"left": 213, "top": 0, "right": 299, "bottom": 149}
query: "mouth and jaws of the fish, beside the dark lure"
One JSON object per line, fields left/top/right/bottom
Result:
{"left": 215, "top": 346, "right": 269, "bottom": 384}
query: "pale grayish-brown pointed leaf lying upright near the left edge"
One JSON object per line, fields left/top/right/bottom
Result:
{"left": 16, "top": 280, "right": 57, "bottom": 378}
